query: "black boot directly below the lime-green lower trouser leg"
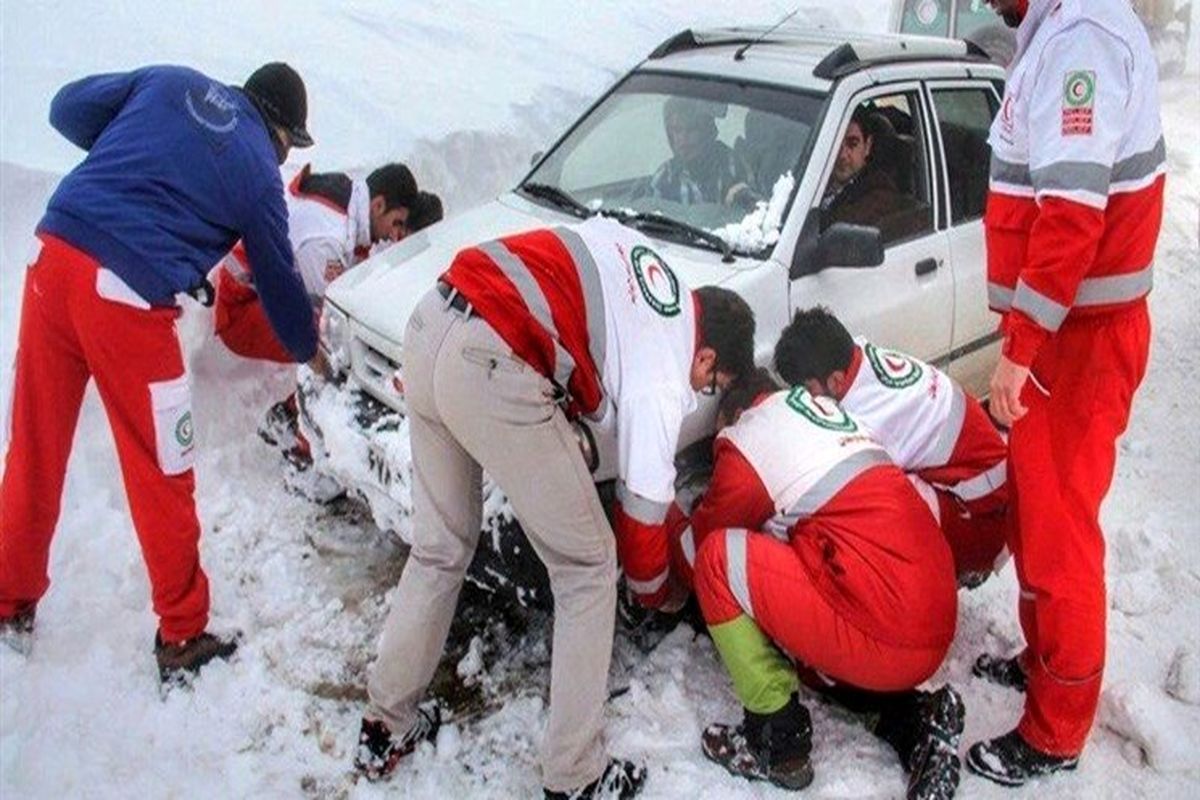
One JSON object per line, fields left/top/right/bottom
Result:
{"left": 701, "top": 694, "right": 812, "bottom": 790}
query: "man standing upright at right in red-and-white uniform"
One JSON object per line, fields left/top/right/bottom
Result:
{"left": 967, "top": 0, "right": 1165, "bottom": 786}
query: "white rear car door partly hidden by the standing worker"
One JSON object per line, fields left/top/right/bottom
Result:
{"left": 926, "top": 80, "right": 1000, "bottom": 395}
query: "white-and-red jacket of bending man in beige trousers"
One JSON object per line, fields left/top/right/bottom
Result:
{"left": 442, "top": 218, "right": 697, "bottom": 606}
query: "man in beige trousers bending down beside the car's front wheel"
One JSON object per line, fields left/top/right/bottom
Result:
{"left": 356, "top": 218, "right": 753, "bottom": 798}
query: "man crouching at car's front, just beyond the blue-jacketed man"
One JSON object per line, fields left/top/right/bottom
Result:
{"left": 214, "top": 163, "right": 420, "bottom": 501}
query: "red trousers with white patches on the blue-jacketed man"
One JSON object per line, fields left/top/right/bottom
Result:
{"left": 0, "top": 235, "right": 209, "bottom": 642}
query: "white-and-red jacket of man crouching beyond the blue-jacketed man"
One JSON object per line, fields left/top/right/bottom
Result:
{"left": 223, "top": 164, "right": 371, "bottom": 306}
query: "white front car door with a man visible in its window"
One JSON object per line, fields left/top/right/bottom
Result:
{"left": 790, "top": 82, "right": 954, "bottom": 360}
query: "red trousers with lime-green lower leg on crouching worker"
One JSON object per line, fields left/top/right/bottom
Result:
{"left": 695, "top": 530, "right": 946, "bottom": 704}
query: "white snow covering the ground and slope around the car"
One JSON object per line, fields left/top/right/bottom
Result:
{"left": 0, "top": 0, "right": 1200, "bottom": 798}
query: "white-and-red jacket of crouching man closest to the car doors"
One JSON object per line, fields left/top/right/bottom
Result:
{"left": 839, "top": 338, "right": 1008, "bottom": 513}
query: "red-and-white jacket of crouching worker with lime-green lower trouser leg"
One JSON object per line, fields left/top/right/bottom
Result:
{"left": 676, "top": 387, "right": 956, "bottom": 644}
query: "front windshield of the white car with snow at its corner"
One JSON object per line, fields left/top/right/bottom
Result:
{"left": 521, "top": 72, "right": 826, "bottom": 254}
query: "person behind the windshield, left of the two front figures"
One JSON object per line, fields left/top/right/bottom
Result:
{"left": 650, "top": 97, "right": 757, "bottom": 209}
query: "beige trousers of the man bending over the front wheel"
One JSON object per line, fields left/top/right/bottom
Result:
{"left": 367, "top": 293, "right": 617, "bottom": 790}
